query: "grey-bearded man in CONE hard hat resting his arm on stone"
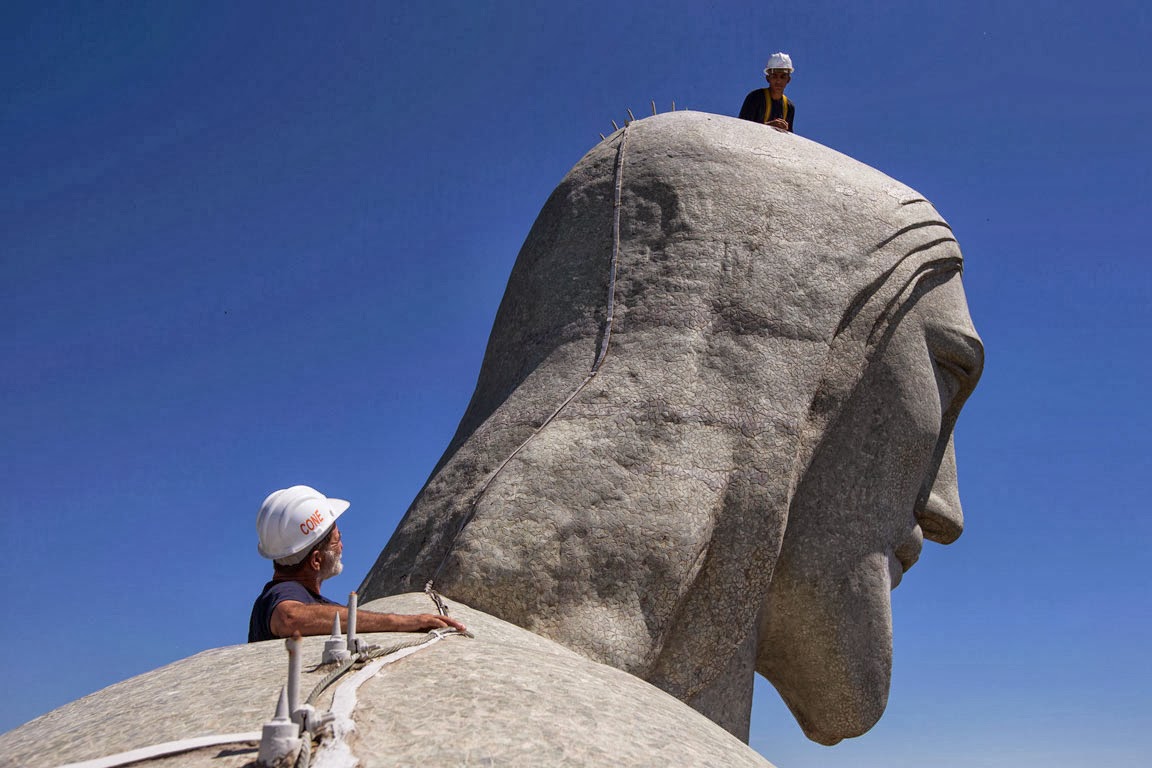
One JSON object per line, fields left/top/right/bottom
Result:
{"left": 248, "top": 486, "right": 464, "bottom": 642}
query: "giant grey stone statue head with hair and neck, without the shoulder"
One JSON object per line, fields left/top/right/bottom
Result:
{"left": 362, "top": 113, "right": 983, "bottom": 743}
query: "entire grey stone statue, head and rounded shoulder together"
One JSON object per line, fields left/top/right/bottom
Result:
{"left": 0, "top": 112, "right": 983, "bottom": 768}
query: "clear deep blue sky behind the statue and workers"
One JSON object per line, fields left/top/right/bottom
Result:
{"left": 0, "top": 0, "right": 1152, "bottom": 768}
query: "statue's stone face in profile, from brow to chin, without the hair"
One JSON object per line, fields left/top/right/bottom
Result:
{"left": 757, "top": 269, "right": 984, "bottom": 744}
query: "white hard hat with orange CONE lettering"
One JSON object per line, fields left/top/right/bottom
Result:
{"left": 256, "top": 486, "right": 351, "bottom": 560}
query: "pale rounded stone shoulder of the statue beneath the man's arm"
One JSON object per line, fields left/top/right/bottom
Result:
{"left": 0, "top": 594, "right": 771, "bottom": 768}
